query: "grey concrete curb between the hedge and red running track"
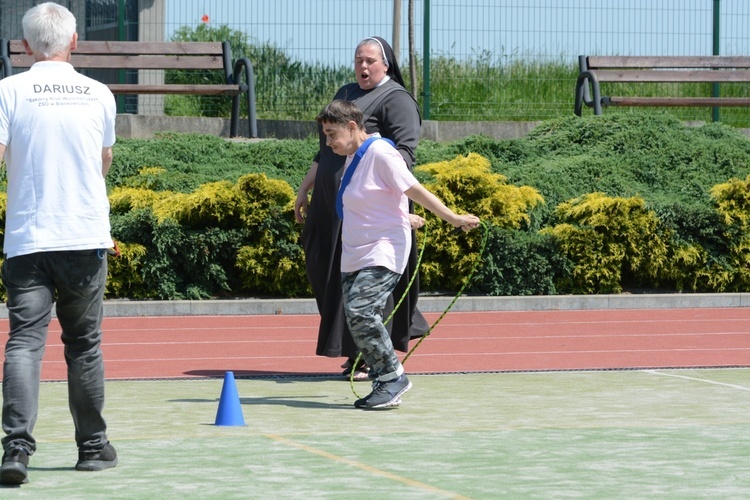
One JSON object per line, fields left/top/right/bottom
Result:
{"left": 69, "top": 293, "right": 750, "bottom": 317}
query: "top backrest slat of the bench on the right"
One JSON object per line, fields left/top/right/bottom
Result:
{"left": 588, "top": 56, "right": 750, "bottom": 70}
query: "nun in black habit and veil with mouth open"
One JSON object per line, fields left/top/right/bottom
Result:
{"left": 295, "top": 37, "right": 429, "bottom": 375}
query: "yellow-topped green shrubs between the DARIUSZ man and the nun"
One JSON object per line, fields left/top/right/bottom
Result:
{"left": 105, "top": 174, "right": 308, "bottom": 299}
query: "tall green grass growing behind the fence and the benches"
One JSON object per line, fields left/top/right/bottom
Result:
{"left": 167, "top": 49, "right": 750, "bottom": 127}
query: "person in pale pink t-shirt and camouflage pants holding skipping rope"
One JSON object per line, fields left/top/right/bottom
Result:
{"left": 317, "top": 100, "right": 479, "bottom": 409}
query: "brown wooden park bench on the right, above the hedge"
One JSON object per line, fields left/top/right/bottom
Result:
{"left": 575, "top": 56, "right": 750, "bottom": 116}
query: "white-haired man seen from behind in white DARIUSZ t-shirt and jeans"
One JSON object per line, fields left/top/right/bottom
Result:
{"left": 0, "top": 2, "right": 117, "bottom": 484}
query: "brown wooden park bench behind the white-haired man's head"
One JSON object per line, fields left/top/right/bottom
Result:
{"left": 0, "top": 40, "right": 258, "bottom": 137}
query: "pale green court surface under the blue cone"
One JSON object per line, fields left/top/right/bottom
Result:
{"left": 10, "top": 369, "right": 750, "bottom": 499}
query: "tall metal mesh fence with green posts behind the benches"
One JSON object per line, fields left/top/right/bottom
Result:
{"left": 0, "top": 0, "right": 750, "bottom": 126}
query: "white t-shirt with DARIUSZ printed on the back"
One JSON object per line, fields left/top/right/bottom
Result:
{"left": 0, "top": 61, "right": 117, "bottom": 257}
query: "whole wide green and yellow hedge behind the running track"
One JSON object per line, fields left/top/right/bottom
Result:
{"left": 0, "top": 113, "right": 750, "bottom": 299}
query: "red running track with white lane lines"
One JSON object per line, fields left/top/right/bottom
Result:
{"left": 0, "top": 308, "right": 750, "bottom": 380}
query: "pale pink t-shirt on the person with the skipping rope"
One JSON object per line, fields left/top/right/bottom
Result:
{"left": 341, "top": 140, "right": 417, "bottom": 274}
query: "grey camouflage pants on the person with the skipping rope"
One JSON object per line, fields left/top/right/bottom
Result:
{"left": 341, "top": 267, "right": 403, "bottom": 378}
